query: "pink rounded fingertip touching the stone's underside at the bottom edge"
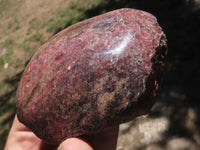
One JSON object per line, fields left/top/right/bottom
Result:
{"left": 58, "top": 138, "right": 94, "bottom": 150}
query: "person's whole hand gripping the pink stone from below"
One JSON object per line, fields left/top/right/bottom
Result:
{"left": 5, "top": 116, "right": 118, "bottom": 150}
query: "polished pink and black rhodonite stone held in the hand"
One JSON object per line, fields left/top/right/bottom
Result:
{"left": 17, "top": 9, "right": 167, "bottom": 144}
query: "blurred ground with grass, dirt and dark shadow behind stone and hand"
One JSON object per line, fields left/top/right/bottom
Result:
{"left": 0, "top": 0, "right": 200, "bottom": 150}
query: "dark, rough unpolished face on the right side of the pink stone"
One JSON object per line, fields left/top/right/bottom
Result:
{"left": 135, "top": 32, "right": 168, "bottom": 115}
